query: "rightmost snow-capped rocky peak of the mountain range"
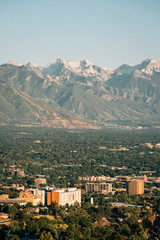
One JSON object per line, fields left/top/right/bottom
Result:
{"left": 107, "top": 59, "right": 160, "bottom": 107}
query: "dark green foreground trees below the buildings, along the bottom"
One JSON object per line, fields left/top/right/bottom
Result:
{"left": 0, "top": 193, "right": 160, "bottom": 240}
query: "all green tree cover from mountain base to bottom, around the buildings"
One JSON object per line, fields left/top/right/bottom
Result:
{"left": 0, "top": 126, "right": 160, "bottom": 240}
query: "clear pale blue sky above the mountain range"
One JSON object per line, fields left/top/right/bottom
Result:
{"left": 0, "top": 0, "right": 160, "bottom": 68}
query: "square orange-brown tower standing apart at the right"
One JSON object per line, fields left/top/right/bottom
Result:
{"left": 128, "top": 179, "right": 144, "bottom": 195}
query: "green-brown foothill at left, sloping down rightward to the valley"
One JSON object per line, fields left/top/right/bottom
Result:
{"left": 0, "top": 83, "right": 93, "bottom": 128}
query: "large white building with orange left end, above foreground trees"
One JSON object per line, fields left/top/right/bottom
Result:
{"left": 47, "top": 188, "right": 81, "bottom": 206}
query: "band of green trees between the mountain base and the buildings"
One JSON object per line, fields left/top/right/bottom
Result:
{"left": 0, "top": 126, "right": 160, "bottom": 186}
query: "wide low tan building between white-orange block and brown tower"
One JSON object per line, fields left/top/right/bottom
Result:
{"left": 86, "top": 183, "right": 112, "bottom": 193}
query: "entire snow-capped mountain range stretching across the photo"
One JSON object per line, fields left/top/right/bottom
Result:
{"left": 0, "top": 59, "right": 160, "bottom": 125}
